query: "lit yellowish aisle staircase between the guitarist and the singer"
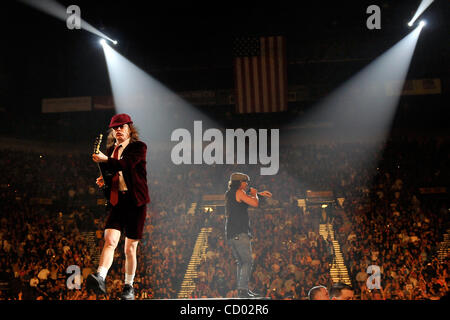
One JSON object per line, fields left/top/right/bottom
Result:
{"left": 178, "top": 228, "right": 212, "bottom": 299}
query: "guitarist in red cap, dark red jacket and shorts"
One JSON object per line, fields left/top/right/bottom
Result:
{"left": 87, "top": 113, "right": 150, "bottom": 300}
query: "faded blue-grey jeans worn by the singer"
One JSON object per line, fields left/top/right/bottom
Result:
{"left": 228, "top": 233, "right": 253, "bottom": 290}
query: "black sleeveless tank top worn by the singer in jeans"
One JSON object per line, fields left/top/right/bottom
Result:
{"left": 225, "top": 190, "right": 251, "bottom": 239}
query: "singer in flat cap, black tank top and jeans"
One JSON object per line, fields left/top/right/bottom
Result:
{"left": 225, "top": 172, "right": 272, "bottom": 298}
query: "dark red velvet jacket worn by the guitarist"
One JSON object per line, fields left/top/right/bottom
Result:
{"left": 102, "top": 141, "right": 150, "bottom": 207}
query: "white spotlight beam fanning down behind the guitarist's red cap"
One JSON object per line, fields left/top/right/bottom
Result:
{"left": 101, "top": 39, "right": 218, "bottom": 140}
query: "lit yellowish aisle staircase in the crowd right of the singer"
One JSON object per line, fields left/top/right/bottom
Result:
{"left": 319, "top": 223, "right": 352, "bottom": 285}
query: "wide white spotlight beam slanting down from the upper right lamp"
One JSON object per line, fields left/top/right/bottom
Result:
{"left": 288, "top": 26, "right": 422, "bottom": 181}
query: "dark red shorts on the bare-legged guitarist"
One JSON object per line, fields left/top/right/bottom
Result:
{"left": 105, "top": 191, "right": 147, "bottom": 240}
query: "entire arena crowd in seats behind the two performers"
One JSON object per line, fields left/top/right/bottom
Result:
{"left": 0, "top": 136, "right": 450, "bottom": 300}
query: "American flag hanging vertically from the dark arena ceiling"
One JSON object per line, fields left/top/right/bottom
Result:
{"left": 234, "top": 36, "right": 287, "bottom": 113}
